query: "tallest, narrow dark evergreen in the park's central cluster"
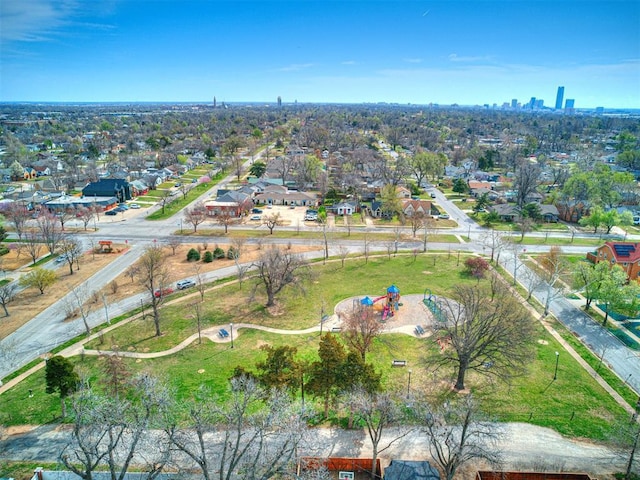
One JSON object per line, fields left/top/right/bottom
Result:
{"left": 306, "top": 333, "right": 347, "bottom": 418}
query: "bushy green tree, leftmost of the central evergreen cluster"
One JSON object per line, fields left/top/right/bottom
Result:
{"left": 256, "top": 345, "right": 301, "bottom": 392}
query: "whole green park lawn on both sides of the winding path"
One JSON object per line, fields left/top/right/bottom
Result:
{"left": 0, "top": 254, "right": 625, "bottom": 440}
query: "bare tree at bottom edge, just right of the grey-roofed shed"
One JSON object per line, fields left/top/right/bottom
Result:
{"left": 416, "top": 395, "right": 502, "bottom": 480}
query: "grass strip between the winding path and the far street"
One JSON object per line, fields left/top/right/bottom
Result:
{"left": 86, "top": 254, "right": 475, "bottom": 352}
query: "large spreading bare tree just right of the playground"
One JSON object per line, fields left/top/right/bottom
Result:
{"left": 428, "top": 285, "right": 533, "bottom": 390}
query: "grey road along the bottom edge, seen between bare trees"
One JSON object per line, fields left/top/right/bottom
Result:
{"left": 0, "top": 423, "right": 625, "bottom": 475}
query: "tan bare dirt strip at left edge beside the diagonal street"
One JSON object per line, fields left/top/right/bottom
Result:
{"left": 0, "top": 245, "right": 125, "bottom": 339}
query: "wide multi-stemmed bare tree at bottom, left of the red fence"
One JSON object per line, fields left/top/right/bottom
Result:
{"left": 166, "top": 376, "right": 308, "bottom": 480}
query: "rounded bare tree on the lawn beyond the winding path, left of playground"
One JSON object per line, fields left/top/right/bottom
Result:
{"left": 256, "top": 247, "right": 307, "bottom": 307}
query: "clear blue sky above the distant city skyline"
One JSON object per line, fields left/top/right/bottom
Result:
{"left": 0, "top": 0, "right": 640, "bottom": 108}
